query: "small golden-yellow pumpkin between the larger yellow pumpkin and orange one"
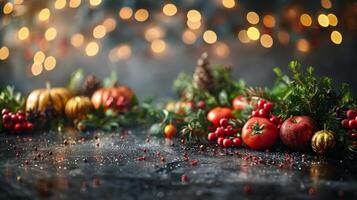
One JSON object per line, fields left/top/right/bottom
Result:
{"left": 65, "top": 96, "right": 93, "bottom": 119}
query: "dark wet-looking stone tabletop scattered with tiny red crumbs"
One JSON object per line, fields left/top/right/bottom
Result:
{"left": 0, "top": 131, "right": 357, "bottom": 199}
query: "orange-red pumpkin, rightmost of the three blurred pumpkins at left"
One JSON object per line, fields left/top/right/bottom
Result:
{"left": 91, "top": 86, "right": 135, "bottom": 112}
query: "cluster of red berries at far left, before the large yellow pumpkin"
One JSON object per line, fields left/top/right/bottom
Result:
{"left": 1, "top": 109, "right": 34, "bottom": 133}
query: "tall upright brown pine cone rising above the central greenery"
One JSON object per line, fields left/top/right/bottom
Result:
{"left": 193, "top": 53, "right": 214, "bottom": 91}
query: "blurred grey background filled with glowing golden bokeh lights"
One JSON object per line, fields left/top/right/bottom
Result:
{"left": 0, "top": 0, "right": 357, "bottom": 98}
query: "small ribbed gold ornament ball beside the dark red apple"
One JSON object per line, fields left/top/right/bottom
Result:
{"left": 311, "top": 130, "right": 336, "bottom": 155}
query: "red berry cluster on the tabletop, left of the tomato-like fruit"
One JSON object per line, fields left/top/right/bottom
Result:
{"left": 208, "top": 118, "right": 242, "bottom": 148}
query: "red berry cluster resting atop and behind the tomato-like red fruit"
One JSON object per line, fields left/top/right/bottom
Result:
{"left": 251, "top": 99, "right": 283, "bottom": 129}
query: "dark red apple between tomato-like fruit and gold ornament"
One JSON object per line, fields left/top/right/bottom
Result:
{"left": 280, "top": 116, "right": 316, "bottom": 151}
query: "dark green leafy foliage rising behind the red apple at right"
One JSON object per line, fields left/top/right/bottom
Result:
{"left": 270, "top": 61, "right": 356, "bottom": 147}
